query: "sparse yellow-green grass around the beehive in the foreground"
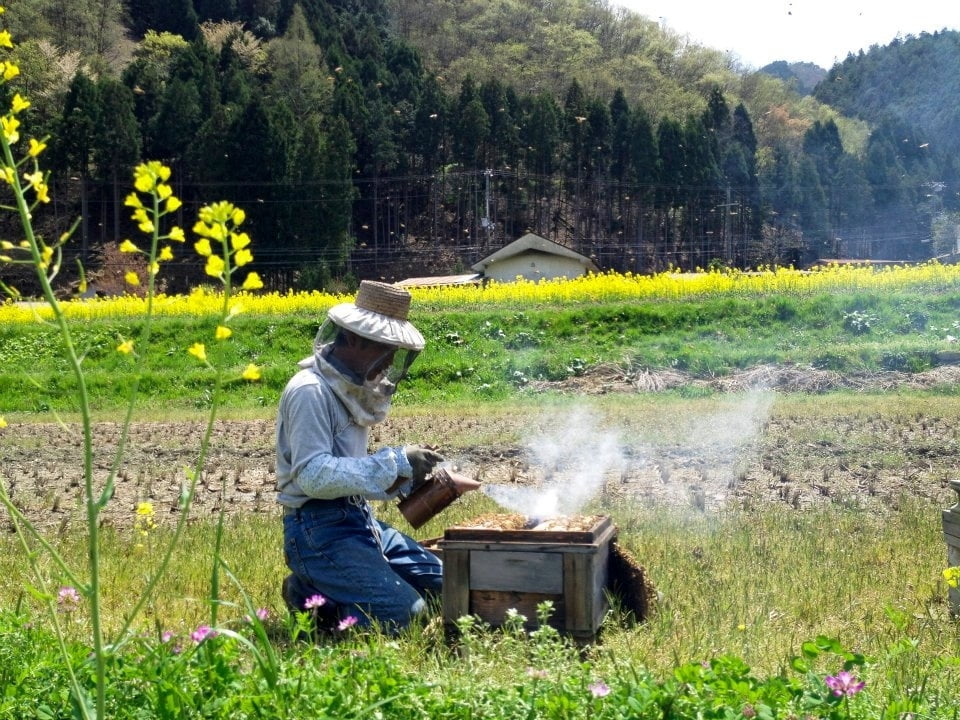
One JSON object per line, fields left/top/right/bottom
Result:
{"left": 0, "top": 486, "right": 960, "bottom": 718}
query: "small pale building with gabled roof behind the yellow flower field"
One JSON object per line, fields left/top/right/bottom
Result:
{"left": 471, "top": 233, "right": 600, "bottom": 282}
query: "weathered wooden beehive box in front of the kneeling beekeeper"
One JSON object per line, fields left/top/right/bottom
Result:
{"left": 438, "top": 516, "right": 617, "bottom": 641}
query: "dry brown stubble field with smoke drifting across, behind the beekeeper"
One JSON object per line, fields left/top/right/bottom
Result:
{"left": 0, "top": 369, "right": 960, "bottom": 531}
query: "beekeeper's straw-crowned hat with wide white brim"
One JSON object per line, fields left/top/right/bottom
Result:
{"left": 327, "top": 280, "right": 426, "bottom": 350}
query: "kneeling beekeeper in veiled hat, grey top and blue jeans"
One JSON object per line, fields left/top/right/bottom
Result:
{"left": 277, "top": 280, "right": 443, "bottom": 629}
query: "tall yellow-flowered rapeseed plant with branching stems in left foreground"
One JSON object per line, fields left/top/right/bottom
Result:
{"left": 0, "top": 15, "right": 263, "bottom": 720}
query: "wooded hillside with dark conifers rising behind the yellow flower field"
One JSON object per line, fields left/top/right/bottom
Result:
{"left": 3, "top": 0, "right": 958, "bottom": 291}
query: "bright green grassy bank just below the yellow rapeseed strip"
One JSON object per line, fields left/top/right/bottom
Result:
{"left": 0, "top": 291, "right": 960, "bottom": 414}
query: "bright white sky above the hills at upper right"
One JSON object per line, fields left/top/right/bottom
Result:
{"left": 611, "top": 0, "right": 960, "bottom": 69}
